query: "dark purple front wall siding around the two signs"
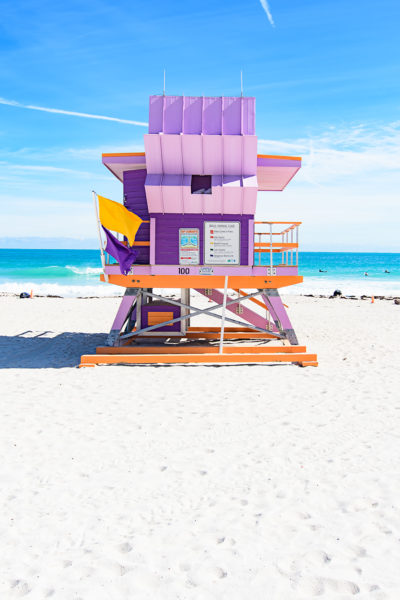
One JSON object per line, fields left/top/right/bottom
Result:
{"left": 151, "top": 214, "right": 254, "bottom": 265}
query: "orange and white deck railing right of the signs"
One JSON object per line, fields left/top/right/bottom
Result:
{"left": 254, "top": 221, "right": 301, "bottom": 268}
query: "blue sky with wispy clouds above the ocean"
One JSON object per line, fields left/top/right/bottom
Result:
{"left": 0, "top": 0, "right": 400, "bottom": 251}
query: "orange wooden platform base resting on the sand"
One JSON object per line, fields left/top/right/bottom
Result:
{"left": 79, "top": 344, "right": 318, "bottom": 367}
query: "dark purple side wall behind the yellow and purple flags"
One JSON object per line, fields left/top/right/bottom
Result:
{"left": 124, "top": 169, "right": 150, "bottom": 265}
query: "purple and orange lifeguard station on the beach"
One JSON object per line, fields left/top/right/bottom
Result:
{"left": 80, "top": 95, "right": 317, "bottom": 366}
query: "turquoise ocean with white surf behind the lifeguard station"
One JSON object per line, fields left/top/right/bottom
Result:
{"left": 0, "top": 249, "right": 400, "bottom": 297}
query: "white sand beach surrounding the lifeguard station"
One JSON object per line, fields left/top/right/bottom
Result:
{"left": 0, "top": 297, "right": 400, "bottom": 600}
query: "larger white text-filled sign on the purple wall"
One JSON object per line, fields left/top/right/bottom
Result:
{"left": 204, "top": 221, "right": 240, "bottom": 265}
